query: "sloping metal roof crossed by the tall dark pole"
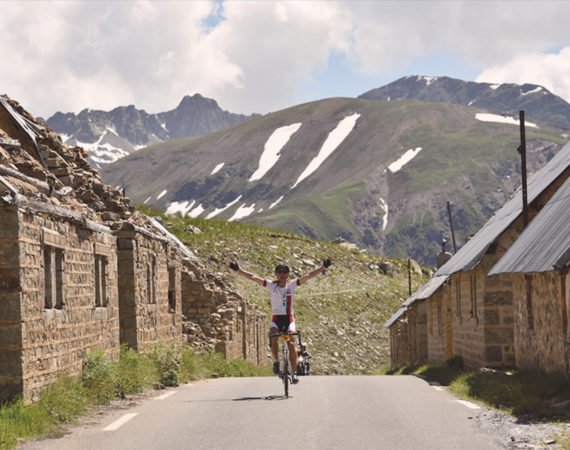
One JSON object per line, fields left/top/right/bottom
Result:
{"left": 435, "top": 143, "right": 570, "bottom": 275}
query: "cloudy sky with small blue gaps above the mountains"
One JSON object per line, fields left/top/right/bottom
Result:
{"left": 0, "top": 0, "right": 570, "bottom": 119}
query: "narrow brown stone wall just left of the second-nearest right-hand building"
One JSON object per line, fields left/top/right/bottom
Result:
{"left": 426, "top": 285, "right": 452, "bottom": 364}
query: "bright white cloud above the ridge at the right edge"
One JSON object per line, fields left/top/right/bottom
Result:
{"left": 476, "top": 47, "right": 570, "bottom": 100}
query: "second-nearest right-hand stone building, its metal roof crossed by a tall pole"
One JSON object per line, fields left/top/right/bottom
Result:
{"left": 435, "top": 144, "right": 570, "bottom": 368}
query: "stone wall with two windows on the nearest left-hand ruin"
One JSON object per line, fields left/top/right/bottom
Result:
{"left": 0, "top": 206, "right": 119, "bottom": 400}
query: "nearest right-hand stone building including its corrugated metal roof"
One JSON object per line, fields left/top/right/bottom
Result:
{"left": 489, "top": 174, "right": 570, "bottom": 375}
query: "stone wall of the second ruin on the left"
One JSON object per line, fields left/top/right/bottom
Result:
{"left": 116, "top": 230, "right": 182, "bottom": 351}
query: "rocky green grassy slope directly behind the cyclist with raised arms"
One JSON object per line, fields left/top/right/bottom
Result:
{"left": 139, "top": 209, "right": 426, "bottom": 374}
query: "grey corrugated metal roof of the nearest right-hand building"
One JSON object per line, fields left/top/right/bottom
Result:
{"left": 489, "top": 178, "right": 570, "bottom": 275}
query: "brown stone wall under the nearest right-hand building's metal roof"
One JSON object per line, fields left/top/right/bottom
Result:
{"left": 513, "top": 271, "right": 570, "bottom": 374}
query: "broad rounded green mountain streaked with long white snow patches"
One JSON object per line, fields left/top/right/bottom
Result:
{"left": 101, "top": 98, "right": 568, "bottom": 265}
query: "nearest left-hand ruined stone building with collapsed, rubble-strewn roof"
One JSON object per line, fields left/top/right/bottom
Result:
{"left": 0, "top": 97, "right": 128, "bottom": 401}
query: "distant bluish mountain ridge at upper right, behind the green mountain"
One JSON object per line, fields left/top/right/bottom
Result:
{"left": 359, "top": 76, "right": 570, "bottom": 129}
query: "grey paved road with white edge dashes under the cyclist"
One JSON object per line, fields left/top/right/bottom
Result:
{"left": 24, "top": 376, "right": 504, "bottom": 450}
